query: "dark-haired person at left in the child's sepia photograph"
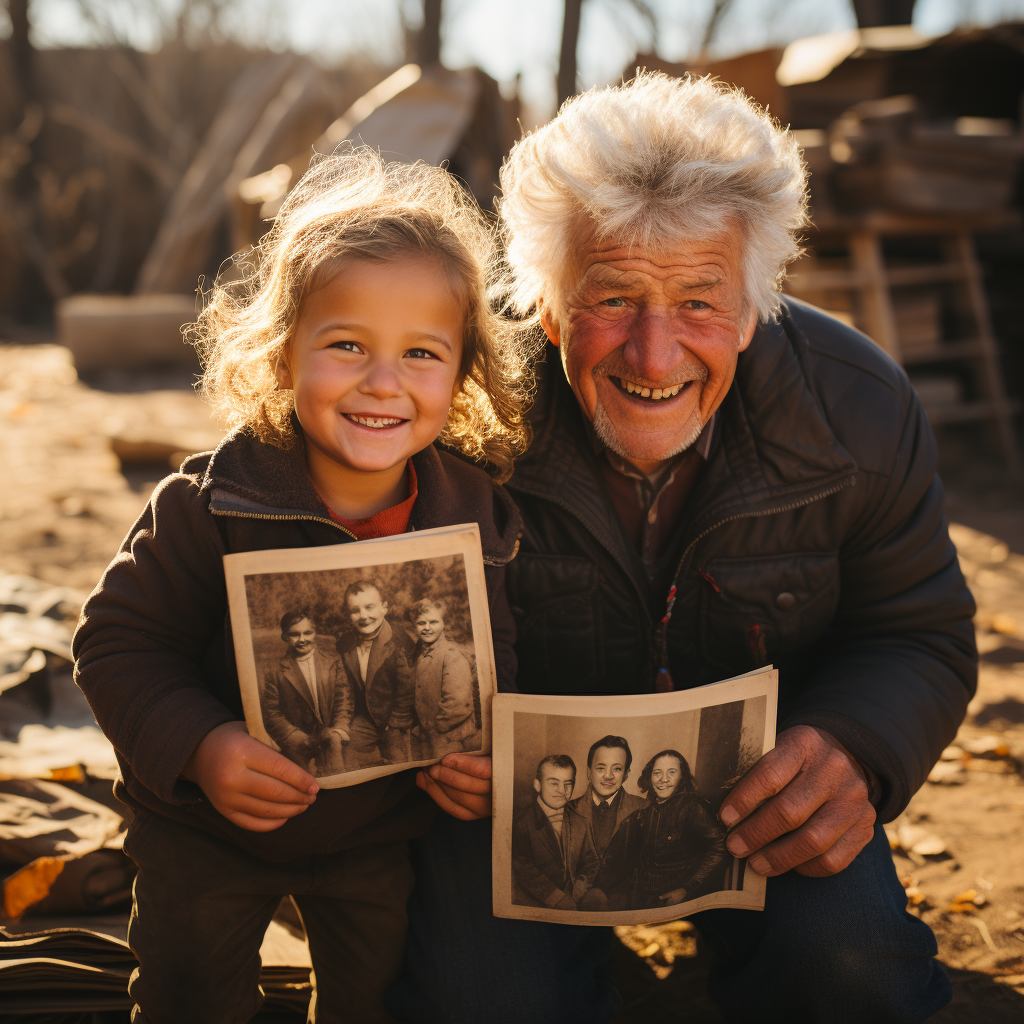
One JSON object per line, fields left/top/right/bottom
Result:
{"left": 263, "top": 608, "right": 352, "bottom": 778}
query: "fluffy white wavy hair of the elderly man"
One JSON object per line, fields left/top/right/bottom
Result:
{"left": 500, "top": 72, "right": 808, "bottom": 321}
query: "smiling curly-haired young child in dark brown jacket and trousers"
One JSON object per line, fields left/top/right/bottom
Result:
{"left": 75, "top": 148, "right": 531, "bottom": 1024}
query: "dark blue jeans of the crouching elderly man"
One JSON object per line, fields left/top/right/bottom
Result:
{"left": 388, "top": 815, "right": 952, "bottom": 1024}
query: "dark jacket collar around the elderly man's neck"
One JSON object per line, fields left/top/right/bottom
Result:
{"left": 509, "top": 300, "right": 857, "bottom": 566}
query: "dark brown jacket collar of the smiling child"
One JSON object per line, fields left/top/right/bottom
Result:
{"left": 182, "top": 430, "right": 521, "bottom": 564}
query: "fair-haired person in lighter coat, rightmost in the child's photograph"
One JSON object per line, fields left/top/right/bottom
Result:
{"left": 411, "top": 598, "right": 480, "bottom": 758}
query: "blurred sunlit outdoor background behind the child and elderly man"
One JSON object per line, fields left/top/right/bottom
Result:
{"left": 0, "top": 0, "right": 1024, "bottom": 1024}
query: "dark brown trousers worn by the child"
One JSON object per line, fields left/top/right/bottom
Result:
{"left": 125, "top": 813, "right": 412, "bottom": 1024}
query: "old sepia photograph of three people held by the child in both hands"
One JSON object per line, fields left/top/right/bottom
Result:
{"left": 224, "top": 523, "right": 495, "bottom": 787}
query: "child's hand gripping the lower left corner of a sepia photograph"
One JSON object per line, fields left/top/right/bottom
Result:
{"left": 181, "top": 722, "right": 319, "bottom": 831}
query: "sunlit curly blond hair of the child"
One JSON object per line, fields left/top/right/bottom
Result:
{"left": 191, "top": 145, "right": 538, "bottom": 480}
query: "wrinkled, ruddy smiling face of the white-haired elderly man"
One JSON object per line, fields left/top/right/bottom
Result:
{"left": 542, "top": 228, "right": 757, "bottom": 469}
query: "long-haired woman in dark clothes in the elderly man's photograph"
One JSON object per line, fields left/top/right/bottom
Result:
{"left": 596, "top": 751, "right": 725, "bottom": 910}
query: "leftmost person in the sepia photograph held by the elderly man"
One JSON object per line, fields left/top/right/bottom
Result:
{"left": 512, "top": 754, "right": 605, "bottom": 910}
